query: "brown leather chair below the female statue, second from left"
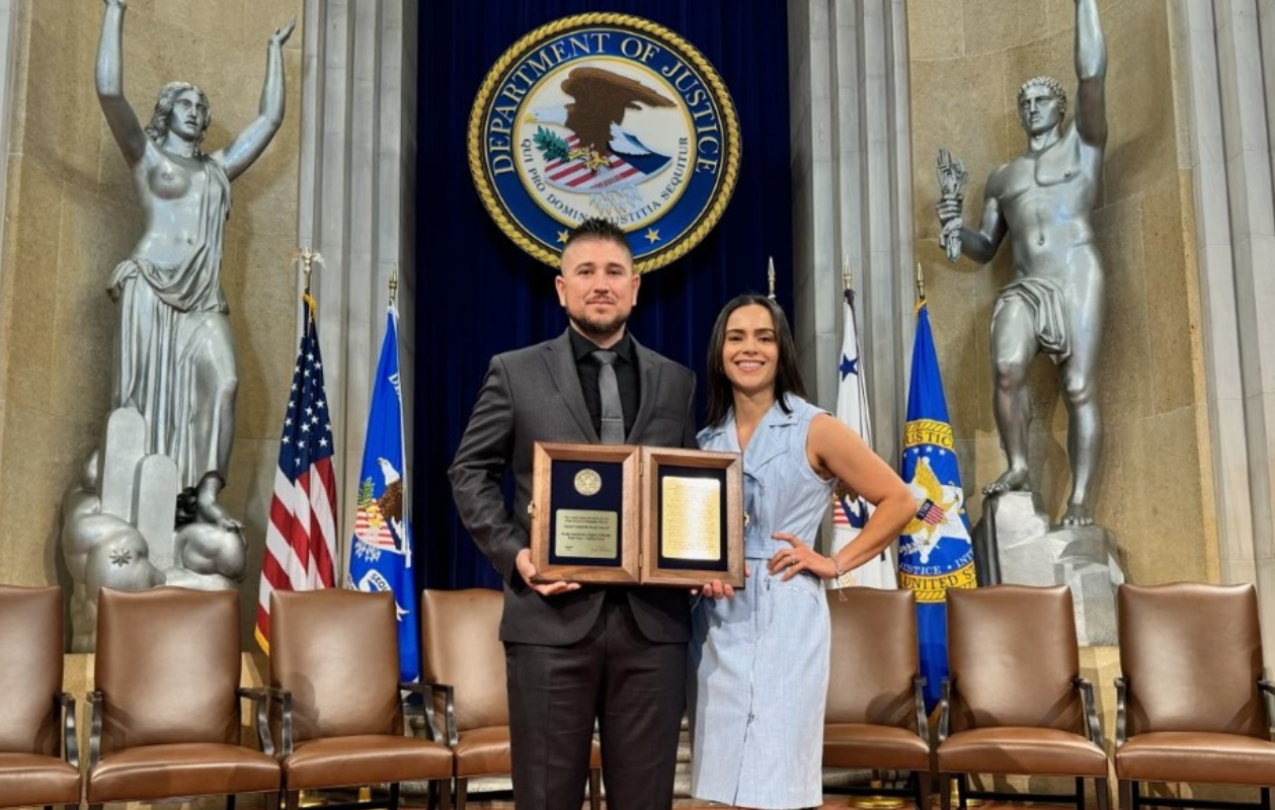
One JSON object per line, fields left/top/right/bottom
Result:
{"left": 85, "top": 588, "right": 279, "bottom": 807}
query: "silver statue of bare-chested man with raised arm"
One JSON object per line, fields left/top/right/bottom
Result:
{"left": 937, "top": 0, "right": 1107, "bottom": 526}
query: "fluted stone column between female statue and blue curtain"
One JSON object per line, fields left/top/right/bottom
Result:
{"left": 297, "top": 0, "right": 418, "bottom": 579}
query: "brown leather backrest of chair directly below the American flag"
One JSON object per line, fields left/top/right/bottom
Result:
{"left": 270, "top": 588, "right": 403, "bottom": 742}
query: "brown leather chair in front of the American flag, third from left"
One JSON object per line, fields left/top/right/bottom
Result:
{"left": 270, "top": 589, "right": 451, "bottom": 810}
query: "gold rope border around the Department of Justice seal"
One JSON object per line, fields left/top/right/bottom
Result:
{"left": 467, "top": 11, "right": 741, "bottom": 273}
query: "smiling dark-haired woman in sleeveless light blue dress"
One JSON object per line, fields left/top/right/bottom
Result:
{"left": 690, "top": 296, "right": 917, "bottom": 810}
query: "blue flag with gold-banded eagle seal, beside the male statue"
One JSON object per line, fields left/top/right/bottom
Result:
{"left": 899, "top": 300, "right": 975, "bottom": 709}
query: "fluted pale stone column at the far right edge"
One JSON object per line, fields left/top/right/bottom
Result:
{"left": 1172, "top": 0, "right": 1275, "bottom": 667}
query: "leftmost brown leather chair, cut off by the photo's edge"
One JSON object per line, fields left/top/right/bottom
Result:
{"left": 0, "top": 585, "right": 80, "bottom": 807}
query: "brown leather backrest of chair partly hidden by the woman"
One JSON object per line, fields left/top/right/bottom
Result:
{"left": 824, "top": 588, "right": 919, "bottom": 731}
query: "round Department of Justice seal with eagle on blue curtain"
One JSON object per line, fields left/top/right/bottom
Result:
{"left": 468, "top": 14, "right": 740, "bottom": 273}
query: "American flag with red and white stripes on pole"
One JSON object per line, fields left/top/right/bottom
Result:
{"left": 256, "top": 293, "right": 337, "bottom": 653}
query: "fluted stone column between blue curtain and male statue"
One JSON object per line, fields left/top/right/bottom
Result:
{"left": 788, "top": 0, "right": 914, "bottom": 466}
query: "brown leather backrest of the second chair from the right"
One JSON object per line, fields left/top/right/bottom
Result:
{"left": 947, "top": 585, "right": 1084, "bottom": 733}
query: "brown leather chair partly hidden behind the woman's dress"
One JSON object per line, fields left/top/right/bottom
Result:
{"left": 824, "top": 588, "right": 931, "bottom": 807}
